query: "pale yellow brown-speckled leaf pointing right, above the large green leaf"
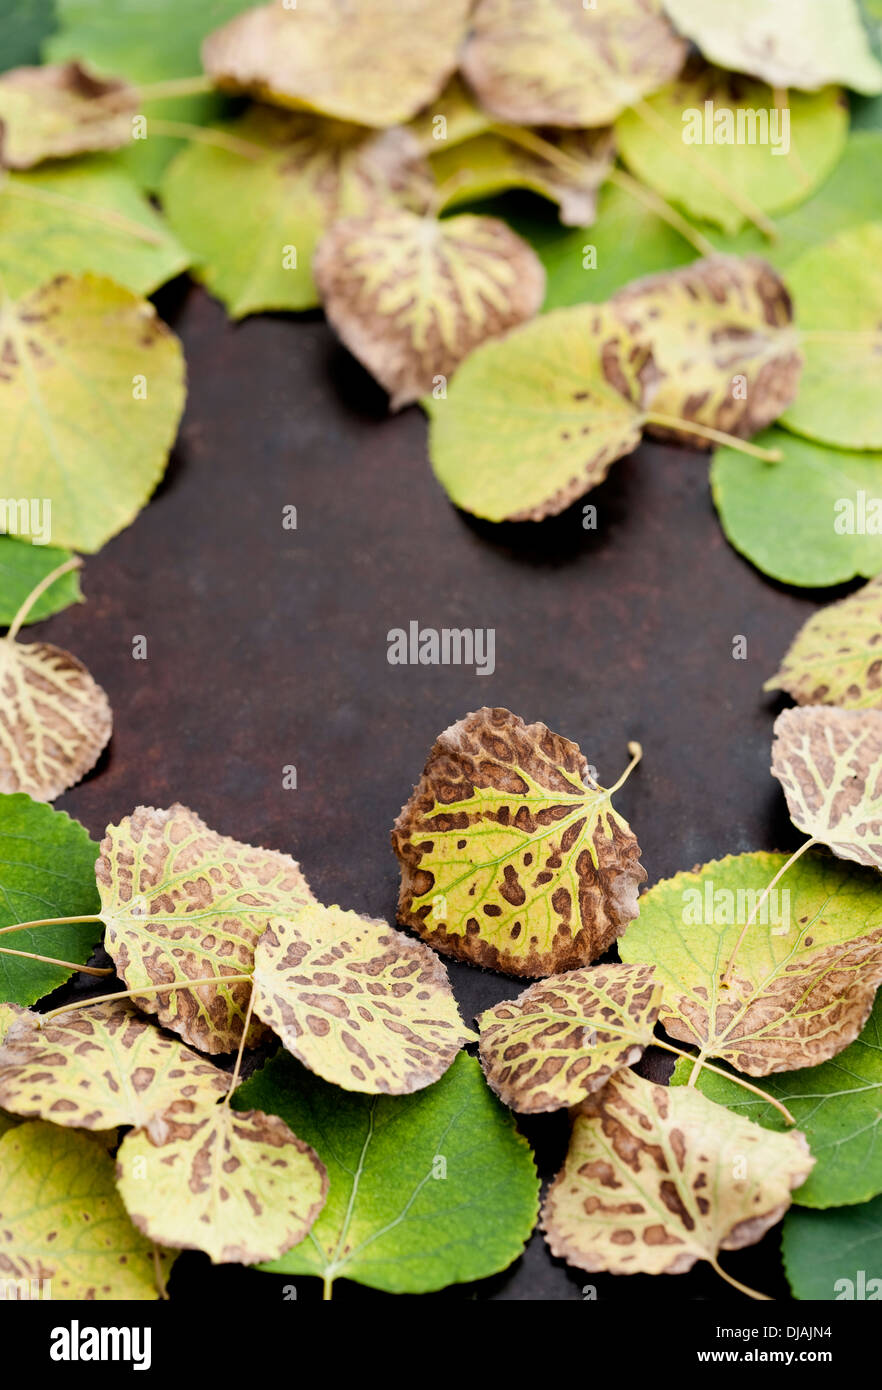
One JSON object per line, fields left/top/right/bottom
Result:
{"left": 254, "top": 904, "right": 476, "bottom": 1104}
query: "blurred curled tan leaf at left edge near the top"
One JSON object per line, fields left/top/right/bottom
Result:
{"left": 0, "top": 63, "right": 138, "bottom": 170}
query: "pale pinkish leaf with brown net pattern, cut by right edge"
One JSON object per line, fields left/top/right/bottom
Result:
{"left": 772, "top": 705, "right": 882, "bottom": 869}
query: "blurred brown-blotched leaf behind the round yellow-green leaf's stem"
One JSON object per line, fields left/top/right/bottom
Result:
{"left": 608, "top": 256, "right": 803, "bottom": 448}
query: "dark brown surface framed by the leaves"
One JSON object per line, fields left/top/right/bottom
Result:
{"left": 46, "top": 282, "right": 835, "bottom": 1304}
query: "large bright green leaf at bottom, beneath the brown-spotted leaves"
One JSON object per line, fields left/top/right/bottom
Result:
{"left": 235, "top": 1054, "right": 539, "bottom": 1294}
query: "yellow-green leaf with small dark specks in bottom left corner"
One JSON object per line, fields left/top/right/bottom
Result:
{"left": 0, "top": 1120, "right": 174, "bottom": 1301}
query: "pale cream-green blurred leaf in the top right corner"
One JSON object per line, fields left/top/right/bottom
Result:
{"left": 664, "top": 0, "right": 882, "bottom": 92}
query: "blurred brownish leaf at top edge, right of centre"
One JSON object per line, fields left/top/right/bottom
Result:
{"left": 461, "top": 0, "right": 688, "bottom": 126}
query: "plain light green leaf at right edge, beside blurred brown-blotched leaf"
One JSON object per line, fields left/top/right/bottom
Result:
{"left": 781, "top": 222, "right": 882, "bottom": 449}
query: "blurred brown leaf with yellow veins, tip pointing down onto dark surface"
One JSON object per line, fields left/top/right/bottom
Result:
{"left": 313, "top": 210, "right": 544, "bottom": 410}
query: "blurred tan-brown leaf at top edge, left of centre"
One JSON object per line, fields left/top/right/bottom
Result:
{"left": 203, "top": 0, "right": 471, "bottom": 126}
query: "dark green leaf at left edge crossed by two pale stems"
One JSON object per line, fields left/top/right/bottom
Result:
{"left": 0, "top": 792, "right": 101, "bottom": 1004}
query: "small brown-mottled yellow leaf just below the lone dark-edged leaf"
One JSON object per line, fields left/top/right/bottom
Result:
{"left": 475, "top": 965, "right": 661, "bottom": 1115}
